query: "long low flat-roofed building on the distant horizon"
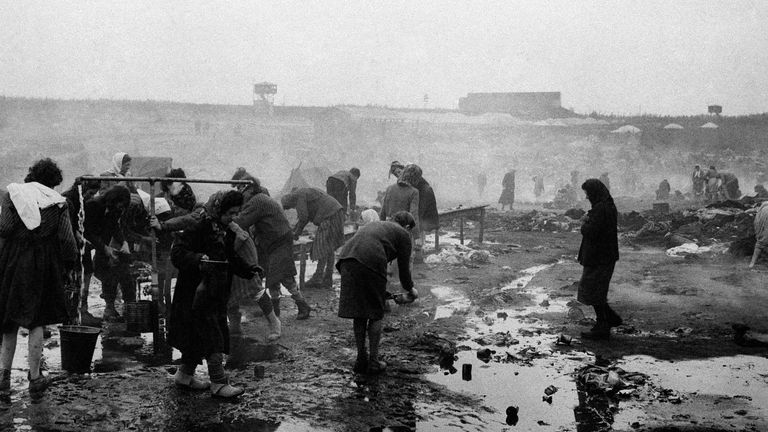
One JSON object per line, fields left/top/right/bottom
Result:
{"left": 459, "top": 92, "right": 563, "bottom": 117}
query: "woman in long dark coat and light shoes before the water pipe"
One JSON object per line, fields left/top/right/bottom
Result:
{"left": 168, "top": 190, "right": 262, "bottom": 398}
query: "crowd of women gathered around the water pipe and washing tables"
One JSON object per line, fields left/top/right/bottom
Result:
{"left": 0, "top": 153, "right": 428, "bottom": 398}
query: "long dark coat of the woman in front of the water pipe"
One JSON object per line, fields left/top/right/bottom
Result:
{"left": 168, "top": 217, "right": 254, "bottom": 358}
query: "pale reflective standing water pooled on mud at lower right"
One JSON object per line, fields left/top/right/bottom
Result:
{"left": 419, "top": 264, "right": 768, "bottom": 431}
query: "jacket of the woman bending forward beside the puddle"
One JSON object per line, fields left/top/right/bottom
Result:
{"left": 336, "top": 221, "right": 413, "bottom": 290}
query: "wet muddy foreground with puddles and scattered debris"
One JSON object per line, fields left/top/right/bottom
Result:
{"left": 0, "top": 207, "right": 768, "bottom": 431}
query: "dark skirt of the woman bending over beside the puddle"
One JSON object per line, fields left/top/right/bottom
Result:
{"left": 339, "top": 259, "right": 387, "bottom": 320}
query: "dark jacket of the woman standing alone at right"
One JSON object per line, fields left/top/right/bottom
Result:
{"left": 578, "top": 200, "right": 619, "bottom": 266}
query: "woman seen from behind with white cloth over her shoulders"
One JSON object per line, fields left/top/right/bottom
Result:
{"left": 0, "top": 159, "right": 78, "bottom": 396}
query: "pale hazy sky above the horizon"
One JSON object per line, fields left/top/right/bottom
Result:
{"left": 0, "top": 0, "right": 768, "bottom": 114}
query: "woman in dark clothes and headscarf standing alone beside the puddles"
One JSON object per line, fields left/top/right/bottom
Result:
{"left": 577, "top": 178, "right": 622, "bottom": 339}
